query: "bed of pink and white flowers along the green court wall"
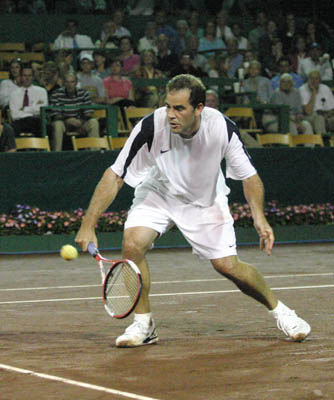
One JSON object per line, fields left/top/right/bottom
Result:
{"left": 0, "top": 201, "right": 334, "bottom": 236}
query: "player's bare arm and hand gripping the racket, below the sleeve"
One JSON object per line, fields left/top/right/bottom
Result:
{"left": 75, "top": 168, "right": 123, "bottom": 251}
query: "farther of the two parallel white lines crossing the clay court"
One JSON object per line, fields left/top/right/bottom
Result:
{"left": 0, "top": 272, "right": 334, "bottom": 292}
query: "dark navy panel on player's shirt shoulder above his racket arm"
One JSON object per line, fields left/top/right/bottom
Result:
{"left": 121, "top": 113, "right": 154, "bottom": 179}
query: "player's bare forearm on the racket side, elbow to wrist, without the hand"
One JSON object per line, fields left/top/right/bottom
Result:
{"left": 82, "top": 168, "right": 123, "bottom": 229}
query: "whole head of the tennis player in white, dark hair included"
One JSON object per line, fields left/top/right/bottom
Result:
{"left": 166, "top": 74, "right": 206, "bottom": 137}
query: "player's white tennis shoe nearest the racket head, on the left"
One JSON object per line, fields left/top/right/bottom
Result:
{"left": 116, "top": 319, "right": 159, "bottom": 347}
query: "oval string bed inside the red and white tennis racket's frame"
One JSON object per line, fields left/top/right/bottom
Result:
{"left": 104, "top": 262, "right": 139, "bottom": 315}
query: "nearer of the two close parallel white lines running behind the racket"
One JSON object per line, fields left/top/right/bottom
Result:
{"left": 0, "top": 285, "right": 334, "bottom": 305}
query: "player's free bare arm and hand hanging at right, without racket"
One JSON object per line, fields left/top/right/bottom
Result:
{"left": 242, "top": 174, "right": 275, "bottom": 256}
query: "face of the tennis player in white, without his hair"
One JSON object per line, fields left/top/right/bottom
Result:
{"left": 166, "top": 89, "right": 203, "bottom": 136}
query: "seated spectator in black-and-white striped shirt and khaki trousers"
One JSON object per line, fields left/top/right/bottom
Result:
{"left": 51, "top": 73, "right": 99, "bottom": 151}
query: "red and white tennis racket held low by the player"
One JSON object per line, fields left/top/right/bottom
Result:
{"left": 88, "top": 242, "right": 143, "bottom": 319}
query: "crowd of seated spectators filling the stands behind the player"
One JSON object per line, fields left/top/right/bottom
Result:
{"left": 0, "top": 0, "right": 334, "bottom": 151}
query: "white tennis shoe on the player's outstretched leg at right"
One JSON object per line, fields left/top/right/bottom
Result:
{"left": 274, "top": 307, "right": 311, "bottom": 342}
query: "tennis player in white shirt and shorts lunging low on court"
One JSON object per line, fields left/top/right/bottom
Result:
{"left": 76, "top": 75, "right": 311, "bottom": 347}
